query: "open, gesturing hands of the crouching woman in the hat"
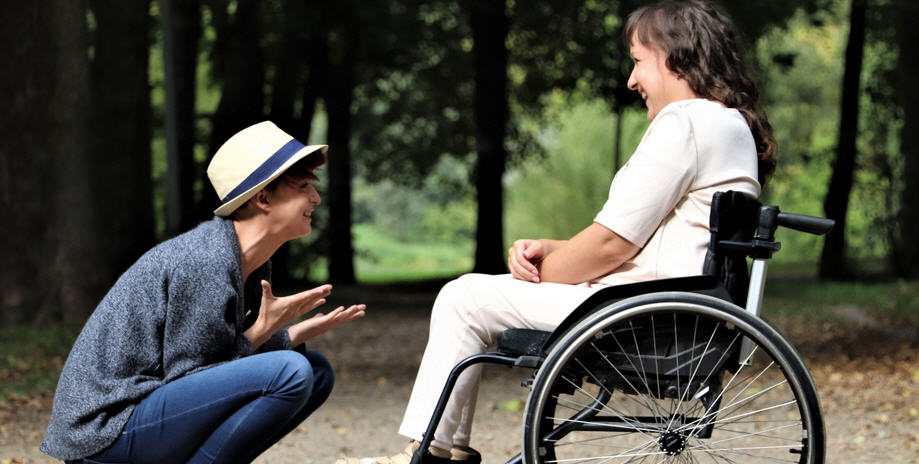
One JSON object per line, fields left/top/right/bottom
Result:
{"left": 244, "top": 280, "right": 367, "bottom": 349}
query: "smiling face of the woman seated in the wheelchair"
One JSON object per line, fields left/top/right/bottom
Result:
{"left": 628, "top": 34, "right": 698, "bottom": 121}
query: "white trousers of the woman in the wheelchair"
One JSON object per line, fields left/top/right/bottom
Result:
{"left": 399, "top": 274, "right": 598, "bottom": 450}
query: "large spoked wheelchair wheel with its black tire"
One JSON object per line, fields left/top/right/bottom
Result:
{"left": 523, "top": 292, "right": 825, "bottom": 464}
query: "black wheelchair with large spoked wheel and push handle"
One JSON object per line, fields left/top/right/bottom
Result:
{"left": 412, "top": 191, "right": 834, "bottom": 464}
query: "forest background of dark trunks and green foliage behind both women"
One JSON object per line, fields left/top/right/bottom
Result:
{"left": 0, "top": 0, "right": 919, "bottom": 392}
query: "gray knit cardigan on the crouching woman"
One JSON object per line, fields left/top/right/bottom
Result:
{"left": 41, "top": 217, "right": 290, "bottom": 460}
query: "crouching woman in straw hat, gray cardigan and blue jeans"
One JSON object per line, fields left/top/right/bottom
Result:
{"left": 41, "top": 121, "right": 365, "bottom": 463}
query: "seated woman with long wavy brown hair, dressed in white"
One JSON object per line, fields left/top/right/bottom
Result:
{"left": 339, "top": 0, "right": 775, "bottom": 464}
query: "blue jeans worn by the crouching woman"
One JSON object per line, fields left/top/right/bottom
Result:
{"left": 75, "top": 350, "right": 334, "bottom": 463}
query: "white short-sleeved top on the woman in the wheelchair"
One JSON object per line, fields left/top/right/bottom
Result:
{"left": 592, "top": 99, "right": 760, "bottom": 285}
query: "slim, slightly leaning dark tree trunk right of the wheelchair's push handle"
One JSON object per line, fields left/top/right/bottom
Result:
{"left": 820, "top": 0, "right": 866, "bottom": 279}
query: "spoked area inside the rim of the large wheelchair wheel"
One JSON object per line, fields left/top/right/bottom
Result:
{"left": 541, "top": 313, "right": 807, "bottom": 464}
